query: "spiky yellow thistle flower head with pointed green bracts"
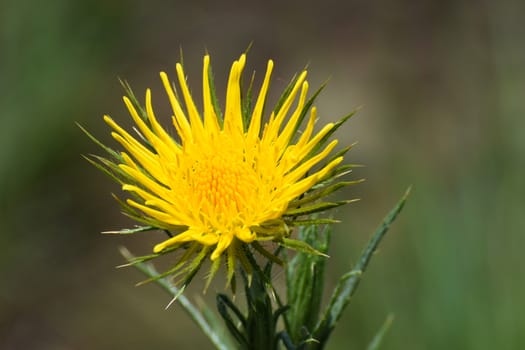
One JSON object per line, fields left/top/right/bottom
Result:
{"left": 88, "top": 54, "right": 357, "bottom": 287}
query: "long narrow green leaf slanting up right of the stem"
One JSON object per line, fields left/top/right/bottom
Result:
{"left": 314, "top": 188, "right": 410, "bottom": 348}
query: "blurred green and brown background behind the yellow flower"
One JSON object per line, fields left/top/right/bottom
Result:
{"left": 0, "top": 0, "right": 525, "bottom": 350}
